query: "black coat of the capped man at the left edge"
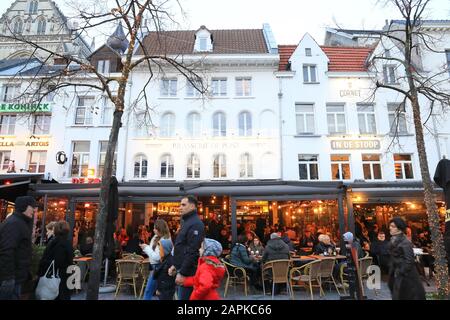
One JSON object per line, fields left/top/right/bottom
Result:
{"left": 0, "top": 212, "right": 33, "bottom": 283}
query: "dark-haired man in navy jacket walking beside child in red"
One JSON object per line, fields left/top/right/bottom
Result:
{"left": 169, "top": 196, "right": 205, "bottom": 300}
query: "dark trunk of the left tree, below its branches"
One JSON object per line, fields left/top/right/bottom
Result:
{"left": 86, "top": 107, "right": 123, "bottom": 300}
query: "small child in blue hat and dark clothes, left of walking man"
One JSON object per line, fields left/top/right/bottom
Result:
{"left": 153, "top": 238, "right": 175, "bottom": 300}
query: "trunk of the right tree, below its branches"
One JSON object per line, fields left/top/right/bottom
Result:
{"left": 411, "top": 95, "right": 448, "bottom": 297}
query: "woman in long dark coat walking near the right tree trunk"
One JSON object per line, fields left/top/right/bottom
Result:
{"left": 388, "top": 217, "right": 425, "bottom": 300}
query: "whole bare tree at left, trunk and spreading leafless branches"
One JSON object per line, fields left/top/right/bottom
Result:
{"left": 0, "top": 0, "right": 206, "bottom": 300}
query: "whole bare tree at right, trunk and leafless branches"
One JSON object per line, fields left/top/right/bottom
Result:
{"left": 371, "top": 0, "right": 450, "bottom": 297}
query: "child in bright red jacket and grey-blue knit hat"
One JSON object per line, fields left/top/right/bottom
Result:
{"left": 183, "top": 238, "right": 225, "bottom": 300}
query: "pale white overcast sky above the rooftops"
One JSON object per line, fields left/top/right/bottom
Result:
{"left": 0, "top": 0, "right": 450, "bottom": 44}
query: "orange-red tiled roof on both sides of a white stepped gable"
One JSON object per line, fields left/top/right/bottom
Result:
{"left": 278, "top": 45, "right": 374, "bottom": 72}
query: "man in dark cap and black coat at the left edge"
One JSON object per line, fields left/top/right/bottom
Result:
{"left": 0, "top": 196, "right": 38, "bottom": 300}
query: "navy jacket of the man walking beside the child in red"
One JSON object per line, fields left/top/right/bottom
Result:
{"left": 173, "top": 210, "right": 205, "bottom": 277}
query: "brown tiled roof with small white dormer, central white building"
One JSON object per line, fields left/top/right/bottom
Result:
{"left": 136, "top": 29, "right": 269, "bottom": 55}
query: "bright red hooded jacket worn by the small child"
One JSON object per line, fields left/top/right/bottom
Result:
{"left": 184, "top": 256, "right": 225, "bottom": 300}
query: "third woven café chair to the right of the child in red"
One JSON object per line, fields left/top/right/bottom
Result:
{"left": 289, "top": 260, "right": 322, "bottom": 300}
